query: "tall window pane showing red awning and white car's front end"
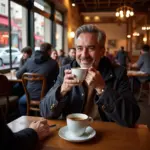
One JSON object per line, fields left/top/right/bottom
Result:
{"left": 11, "top": 2, "right": 27, "bottom": 67}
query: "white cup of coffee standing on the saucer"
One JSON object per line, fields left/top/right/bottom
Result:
{"left": 67, "top": 113, "right": 93, "bottom": 137}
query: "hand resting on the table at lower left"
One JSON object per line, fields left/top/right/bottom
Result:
{"left": 29, "top": 119, "right": 50, "bottom": 140}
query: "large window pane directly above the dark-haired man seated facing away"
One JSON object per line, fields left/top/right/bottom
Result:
{"left": 34, "top": 13, "right": 51, "bottom": 50}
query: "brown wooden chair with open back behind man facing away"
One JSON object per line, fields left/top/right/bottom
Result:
{"left": 22, "top": 73, "right": 46, "bottom": 115}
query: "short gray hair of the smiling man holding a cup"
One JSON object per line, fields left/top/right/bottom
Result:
{"left": 75, "top": 24, "right": 106, "bottom": 48}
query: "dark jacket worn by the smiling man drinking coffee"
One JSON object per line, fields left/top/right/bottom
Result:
{"left": 40, "top": 57, "right": 140, "bottom": 127}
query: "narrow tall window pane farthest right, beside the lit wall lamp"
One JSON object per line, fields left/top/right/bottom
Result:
{"left": 55, "top": 24, "right": 63, "bottom": 50}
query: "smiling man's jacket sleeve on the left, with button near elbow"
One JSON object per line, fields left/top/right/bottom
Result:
{"left": 40, "top": 68, "right": 68, "bottom": 119}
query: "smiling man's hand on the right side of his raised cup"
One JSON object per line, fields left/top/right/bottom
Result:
{"left": 85, "top": 67, "right": 105, "bottom": 93}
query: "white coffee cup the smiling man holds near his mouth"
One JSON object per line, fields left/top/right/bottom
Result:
{"left": 71, "top": 68, "right": 88, "bottom": 81}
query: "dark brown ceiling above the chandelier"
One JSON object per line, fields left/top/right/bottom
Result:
{"left": 72, "top": 0, "right": 150, "bottom": 12}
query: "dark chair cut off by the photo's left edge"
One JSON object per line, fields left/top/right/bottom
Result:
{"left": 0, "top": 74, "right": 19, "bottom": 119}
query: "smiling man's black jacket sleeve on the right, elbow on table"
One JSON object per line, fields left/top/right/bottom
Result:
{"left": 96, "top": 70, "right": 140, "bottom": 127}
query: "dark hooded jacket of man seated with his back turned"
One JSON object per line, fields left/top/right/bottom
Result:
{"left": 16, "top": 51, "right": 59, "bottom": 99}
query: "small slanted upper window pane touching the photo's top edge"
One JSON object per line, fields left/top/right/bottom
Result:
{"left": 34, "top": 0, "right": 51, "bottom": 13}
